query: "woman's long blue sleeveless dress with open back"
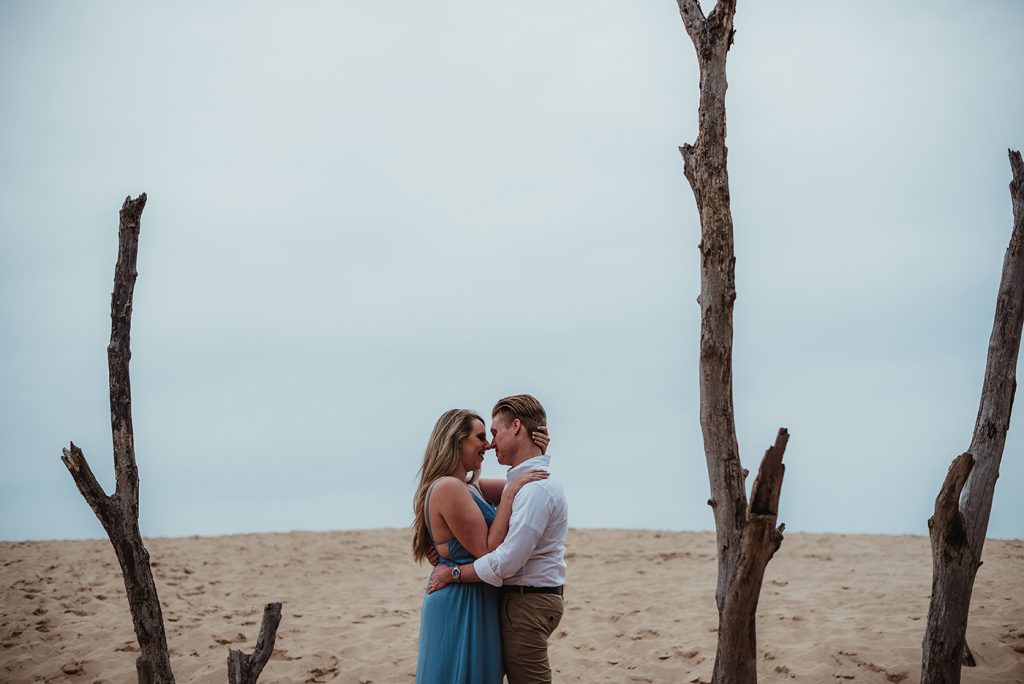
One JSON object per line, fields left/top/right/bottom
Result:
{"left": 416, "top": 482, "right": 505, "bottom": 684}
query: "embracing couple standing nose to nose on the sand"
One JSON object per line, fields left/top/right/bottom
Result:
{"left": 413, "top": 394, "right": 568, "bottom": 684}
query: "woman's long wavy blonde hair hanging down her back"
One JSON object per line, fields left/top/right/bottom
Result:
{"left": 413, "top": 409, "right": 483, "bottom": 561}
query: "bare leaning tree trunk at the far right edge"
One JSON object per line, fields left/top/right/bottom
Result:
{"left": 921, "top": 151, "right": 1024, "bottom": 684}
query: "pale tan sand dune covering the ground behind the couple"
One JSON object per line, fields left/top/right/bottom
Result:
{"left": 0, "top": 529, "right": 1024, "bottom": 684}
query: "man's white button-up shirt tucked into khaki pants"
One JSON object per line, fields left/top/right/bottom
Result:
{"left": 473, "top": 455, "right": 569, "bottom": 587}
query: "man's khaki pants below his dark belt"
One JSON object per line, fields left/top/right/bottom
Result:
{"left": 502, "top": 594, "right": 563, "bottom": 684}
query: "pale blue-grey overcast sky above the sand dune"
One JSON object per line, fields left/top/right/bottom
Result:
{"left": 0, "top": 0, "right": 1024, "bottom": 540}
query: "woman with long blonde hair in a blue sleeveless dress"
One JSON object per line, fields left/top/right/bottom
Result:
{"left": 413, "top": 409, "right": 548, "bottom": 684}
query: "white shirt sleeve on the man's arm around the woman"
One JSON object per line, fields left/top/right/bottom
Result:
{"left": 473, "top": 484, "right": 551, "bottom": 587}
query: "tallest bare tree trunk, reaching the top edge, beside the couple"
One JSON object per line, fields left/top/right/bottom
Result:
{"left": 678, "top": 0, "right": 788, "bottom": 684}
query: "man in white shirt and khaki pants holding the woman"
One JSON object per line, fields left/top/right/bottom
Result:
{"left": 430, "top": 394, "right": 568, "bottom": 684}
